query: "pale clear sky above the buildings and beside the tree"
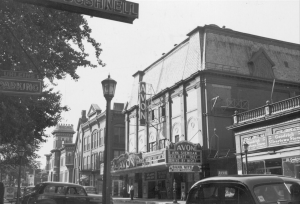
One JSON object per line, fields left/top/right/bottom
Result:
{"left": 38, "top": 0, "right": 300, "bottom": 168}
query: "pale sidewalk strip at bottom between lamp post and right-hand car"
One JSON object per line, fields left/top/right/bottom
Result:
{"left": 113, "top": 197, "right": 185, "bottom": 204}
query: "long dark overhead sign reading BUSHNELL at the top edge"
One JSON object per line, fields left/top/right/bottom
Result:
{"left": 15, "top": 0, "right": 139, "bottom": 23}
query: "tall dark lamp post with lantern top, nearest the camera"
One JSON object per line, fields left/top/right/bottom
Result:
{"left": 101, "top": 75, "right": 117, "bottom": 204}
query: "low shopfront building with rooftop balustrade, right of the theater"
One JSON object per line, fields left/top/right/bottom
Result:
{"left": 228, "top": 95, "right": 300, "bottom": 179}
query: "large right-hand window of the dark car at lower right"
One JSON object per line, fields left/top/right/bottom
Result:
{"left": 254, "top": 183, "right": 291, "bottom": 203}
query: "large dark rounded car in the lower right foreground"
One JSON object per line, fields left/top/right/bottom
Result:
{"left": 186, "top": 174, "right": 300, "bottom": 204}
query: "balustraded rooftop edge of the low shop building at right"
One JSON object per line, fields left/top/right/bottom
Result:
{"left": 233, "top": 95, "right": 300, "bottom": 126}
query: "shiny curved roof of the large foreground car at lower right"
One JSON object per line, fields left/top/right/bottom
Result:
{"left": 192, "top": 174, "right": 300, "bottom": 188}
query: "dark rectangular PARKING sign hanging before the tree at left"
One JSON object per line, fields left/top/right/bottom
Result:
{"left": 0, "top": 70, "right": 42, "bottom": 95}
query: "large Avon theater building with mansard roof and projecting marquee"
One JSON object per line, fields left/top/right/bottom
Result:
{"left": 111, "top": 25, "right": 300, "bottom": 198}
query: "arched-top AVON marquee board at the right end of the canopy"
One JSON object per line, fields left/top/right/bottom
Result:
{"left": 167, "top": 141, "right": 202, "bottom": 165}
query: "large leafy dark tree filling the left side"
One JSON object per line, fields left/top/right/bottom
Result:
{"left": 0, "top": 0, "right": 105, "bottom": 168}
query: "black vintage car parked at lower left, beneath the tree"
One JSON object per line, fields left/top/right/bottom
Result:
{"left": 21, "top": 182, "right": 91, "bottom": 204}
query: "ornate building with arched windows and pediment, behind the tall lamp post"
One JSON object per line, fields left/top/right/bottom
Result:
{"left": 73, "top": 103, "right": 125, "bottom": 195}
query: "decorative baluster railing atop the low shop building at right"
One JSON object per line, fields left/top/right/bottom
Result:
{"left": 233, "top": 95, "right": 300, "bottom": 124}
